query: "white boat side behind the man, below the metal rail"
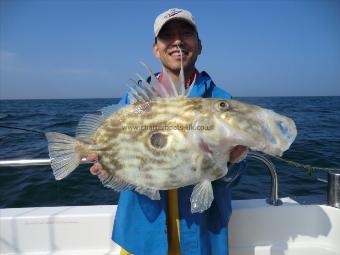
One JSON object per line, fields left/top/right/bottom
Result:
{"left": 0, "top": 198, "right": 340, "bottom": 255}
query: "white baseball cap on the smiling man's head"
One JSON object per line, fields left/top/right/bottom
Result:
{"left": 153, "top": 8, "right": 197, "bottom": 37}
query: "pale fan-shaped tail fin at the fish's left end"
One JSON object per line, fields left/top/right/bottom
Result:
{"left": 45, "top": 132, "right": 84, "bottom": 180}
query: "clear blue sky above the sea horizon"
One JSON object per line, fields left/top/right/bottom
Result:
{"left": 0, "top": 0, "right": 340, "bottom": 99}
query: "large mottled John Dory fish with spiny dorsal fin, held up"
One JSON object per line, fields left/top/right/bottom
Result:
{"left": 46, "top": 62, "right": 297, "bottom": 212}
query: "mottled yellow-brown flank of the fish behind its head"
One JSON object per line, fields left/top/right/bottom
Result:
{"left": 93, "top": 97, "right": 224, "bottom": 190}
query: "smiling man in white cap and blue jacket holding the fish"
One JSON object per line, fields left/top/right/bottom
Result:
{"left": 89, "top": 8, "right": 246, "bottom": 255}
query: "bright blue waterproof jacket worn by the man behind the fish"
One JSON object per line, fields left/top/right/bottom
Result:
{"left": 112, "top": 72, "right": 245, "bottom": 255}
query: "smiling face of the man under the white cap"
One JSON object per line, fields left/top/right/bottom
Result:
{"left": 153, "top": 19, "right": 202, "bottom": 72}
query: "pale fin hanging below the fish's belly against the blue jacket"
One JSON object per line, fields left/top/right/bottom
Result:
{"left": 190, "top": 180, "right": 214, "bottom": 213}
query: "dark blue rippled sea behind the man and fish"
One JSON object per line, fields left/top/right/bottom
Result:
{"left": 0, "top": 97, "right": 340, "bottom": 208}
